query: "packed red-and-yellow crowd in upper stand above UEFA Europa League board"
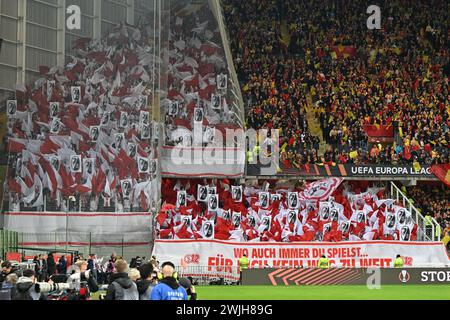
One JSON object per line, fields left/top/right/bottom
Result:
{"left": 225, "top": 0, "right": 450, "bottom": 167}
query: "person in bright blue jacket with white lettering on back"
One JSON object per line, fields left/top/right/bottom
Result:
{"left": 151, "top": 262, "right": 187, "bottom": 300}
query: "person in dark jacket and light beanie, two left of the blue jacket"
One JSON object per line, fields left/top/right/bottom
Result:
{"left": 105, "top": 259, "right": 139, "bottom": 300}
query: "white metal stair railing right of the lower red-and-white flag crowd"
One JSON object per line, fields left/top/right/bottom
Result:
{"left": 390, "top": 181, "right": 441, "bottom": 241}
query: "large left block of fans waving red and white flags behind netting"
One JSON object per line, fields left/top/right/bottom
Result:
{"left": 7, "top": 24, "right": 158, "bottom": 212}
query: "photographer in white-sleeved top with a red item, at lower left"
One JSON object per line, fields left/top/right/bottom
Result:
{"left": 67, "top": 260, "right": 99, "bottom": 300}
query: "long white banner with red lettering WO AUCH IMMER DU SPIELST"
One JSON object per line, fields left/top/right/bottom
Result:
{"left": 153, "top": 240, "right": 450, "bottom": 276}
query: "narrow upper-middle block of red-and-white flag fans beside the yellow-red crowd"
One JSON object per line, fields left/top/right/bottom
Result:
{"left": 163, "top": 6, "right": 243, "bottom": 146}
